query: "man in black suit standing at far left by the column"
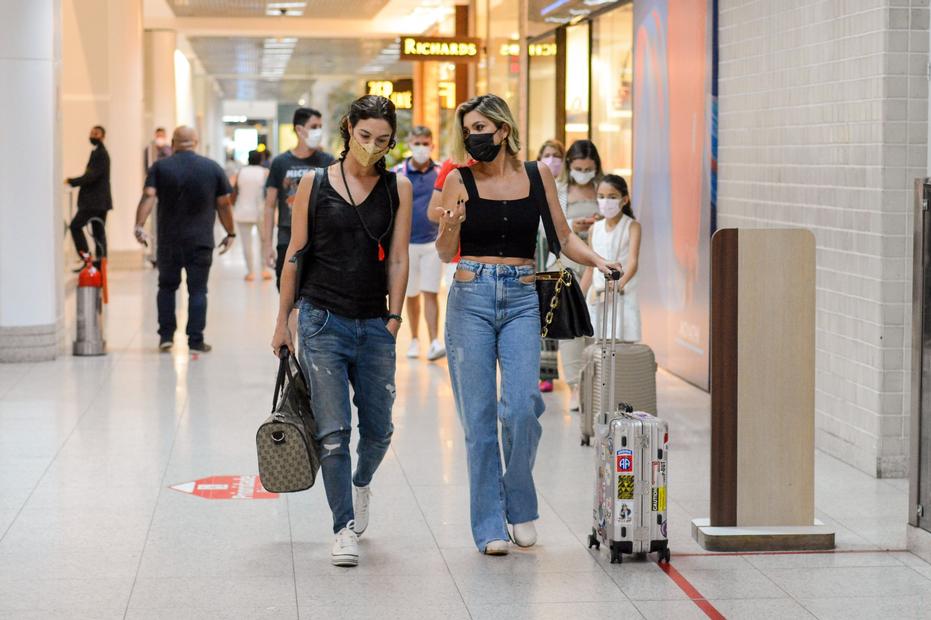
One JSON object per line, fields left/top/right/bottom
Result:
{"left": 65, "top": 125, "right": 113, "bottom": 271}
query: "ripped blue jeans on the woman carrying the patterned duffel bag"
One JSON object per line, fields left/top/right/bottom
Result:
{"left": 298, "top": 299, "right": 397, "bottom": 533}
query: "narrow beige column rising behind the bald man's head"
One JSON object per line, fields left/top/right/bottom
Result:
{"left": 145, "top": 30, "right": 178, "bottom": 139}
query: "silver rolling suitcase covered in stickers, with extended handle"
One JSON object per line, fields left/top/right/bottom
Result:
{"left": 588, "top": 280, "right": 670, "bottom": 564}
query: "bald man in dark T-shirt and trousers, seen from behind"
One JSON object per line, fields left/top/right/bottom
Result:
{"left": 135, "top": 126, "right": 236, "bottom": 353}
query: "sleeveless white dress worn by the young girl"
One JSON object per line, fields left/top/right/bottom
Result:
{"left": 588, "top": 215, "right": 640, "bottom": 342}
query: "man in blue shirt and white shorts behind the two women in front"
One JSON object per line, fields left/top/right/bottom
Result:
{"left": 394, "top": 125, "right": 446, "bottom": 361}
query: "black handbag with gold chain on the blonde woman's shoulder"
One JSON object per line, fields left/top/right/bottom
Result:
{"left": 524, "top": 162, "right": 595, "bottom": 340}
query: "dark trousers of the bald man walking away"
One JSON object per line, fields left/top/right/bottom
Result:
{"left": 158, "top": 242, "right": 213, "bottom": 345}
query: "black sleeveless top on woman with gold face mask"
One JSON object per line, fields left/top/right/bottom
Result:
{"left": 299, "top": 169, "right": 400, "bottom": 319}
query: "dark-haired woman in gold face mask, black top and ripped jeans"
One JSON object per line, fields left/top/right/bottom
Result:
{"left": 272, "top": 95, "right": 412, "bottom": 566}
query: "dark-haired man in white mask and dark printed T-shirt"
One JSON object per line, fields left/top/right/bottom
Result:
{"left": 262, "top": 108, "right": 335, "bottom": 288}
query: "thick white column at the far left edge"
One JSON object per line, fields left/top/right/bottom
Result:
{"left": 0, "top": 0, "right": 62, "bottom": 360}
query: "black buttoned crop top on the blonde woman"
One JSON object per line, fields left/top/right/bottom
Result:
{"left": 459, "top": 162, "right": 549, "bottom": 259}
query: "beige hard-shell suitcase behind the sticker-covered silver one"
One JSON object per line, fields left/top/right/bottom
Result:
{"left": 579, "top": 291, "right": 656, "bottom": 446}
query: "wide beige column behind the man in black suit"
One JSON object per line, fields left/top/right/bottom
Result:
{"left": 61, "top": 0, "right": 143, "bottom": 260}
